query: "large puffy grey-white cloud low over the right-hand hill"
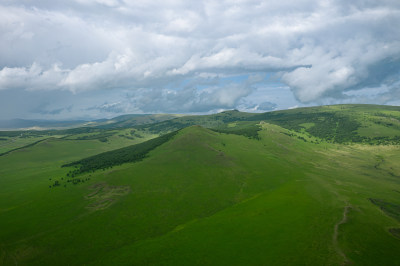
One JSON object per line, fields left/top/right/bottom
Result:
{"left": 282, "top": 29, "right": 400, "bottom": 103}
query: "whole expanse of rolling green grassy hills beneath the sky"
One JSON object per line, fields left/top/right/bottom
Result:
{"left": 0, "top": 105, "right": 400, "bottom": 265}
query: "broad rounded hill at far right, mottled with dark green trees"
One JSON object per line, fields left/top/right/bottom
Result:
{"left": 254, "top": 105, "right": 400, "bottom": 144}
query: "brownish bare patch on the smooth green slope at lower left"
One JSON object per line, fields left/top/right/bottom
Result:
{"left": 85, "top": 183, "right": 131, "bottom": 211}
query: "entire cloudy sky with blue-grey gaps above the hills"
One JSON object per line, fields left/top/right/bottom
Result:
{"left": 0, "top": 0, "right": 400, "bottom": 120}
